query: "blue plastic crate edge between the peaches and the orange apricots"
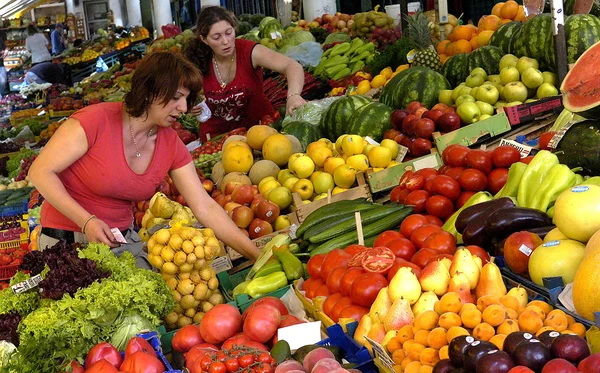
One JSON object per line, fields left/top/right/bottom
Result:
{"left": 317, "top": 324, "right": 379, "bottom": 373}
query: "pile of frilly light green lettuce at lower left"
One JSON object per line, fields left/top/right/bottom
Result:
{"left": 0, "top": 244, "right": 175, "bottom": 373}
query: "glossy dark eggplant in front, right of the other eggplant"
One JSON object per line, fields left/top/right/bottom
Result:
{"left": 482, "top": 207, "right": 552, "bottom": 238}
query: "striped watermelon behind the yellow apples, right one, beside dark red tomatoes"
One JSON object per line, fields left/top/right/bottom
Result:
{"left": 346, "top": 102, "right": 392, "bottom": 141}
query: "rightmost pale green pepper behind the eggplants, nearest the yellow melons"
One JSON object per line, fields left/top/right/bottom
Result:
{"left": 528, "top": 163, "right": 575, "bottom": 212}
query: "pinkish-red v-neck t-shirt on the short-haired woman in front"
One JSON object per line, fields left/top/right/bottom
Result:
{"left": 40, "top": 102, "right": 192, "bottom": 231}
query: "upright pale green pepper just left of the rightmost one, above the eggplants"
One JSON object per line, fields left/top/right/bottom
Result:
{"left": 517, "top": 150, "right": 559, "bottom": 207}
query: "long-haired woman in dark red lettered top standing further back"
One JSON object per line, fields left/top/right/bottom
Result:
{"left": 184, "top": 6, "right": 306, "bottom": 141}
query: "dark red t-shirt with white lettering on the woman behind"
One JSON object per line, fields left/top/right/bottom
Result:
{"left": 200, "top": 39, "right": 273, "bottom": 141}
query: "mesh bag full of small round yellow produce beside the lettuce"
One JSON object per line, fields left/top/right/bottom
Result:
{"left": 148, "top": 222, "right": 224, "bottom": 329}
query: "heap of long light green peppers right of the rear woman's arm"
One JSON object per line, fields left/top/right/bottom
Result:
{"left": 315, "top": 38, "right": 375, "bottom": 81}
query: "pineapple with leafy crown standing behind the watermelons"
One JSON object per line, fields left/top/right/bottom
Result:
{"left": 406, "top": 12, "right": 442, "bottom": 71}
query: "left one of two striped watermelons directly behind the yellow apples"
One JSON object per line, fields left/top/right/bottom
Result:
{"left": 319, "top": 95, "right": 370, "bottom": 141}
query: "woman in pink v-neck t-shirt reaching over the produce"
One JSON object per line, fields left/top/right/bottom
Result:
{"left": 29, "top": 52, "right": 259, "bottom": 268}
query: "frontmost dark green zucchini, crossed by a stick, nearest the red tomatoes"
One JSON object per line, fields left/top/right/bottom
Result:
{"left": 309, "top": 206, "right": 413, "bottom": 256}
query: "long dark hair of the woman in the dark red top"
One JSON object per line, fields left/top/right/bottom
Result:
{"left": 183, "top": 6, "right": 236, "bottom": 75}
